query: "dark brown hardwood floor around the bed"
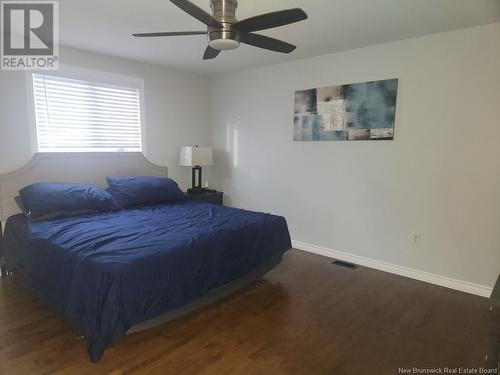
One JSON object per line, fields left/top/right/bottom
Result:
{"left": 0, "top": 250, "right": 490, "bottom": 375}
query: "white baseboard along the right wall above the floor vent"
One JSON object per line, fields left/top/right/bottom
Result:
{"left": 292, "top": 241, "right": 493, "bottom": 298}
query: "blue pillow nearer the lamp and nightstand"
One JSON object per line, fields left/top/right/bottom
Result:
{"left": 107, "top": 176, "right": 186, "bottom": 208}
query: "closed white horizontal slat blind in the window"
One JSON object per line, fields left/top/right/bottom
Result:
{"left": 33, "top": 74, "right": 142, "bottom": 152}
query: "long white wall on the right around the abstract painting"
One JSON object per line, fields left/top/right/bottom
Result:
{"left": 210, "top": 24, "right": 500, "bottom": 286}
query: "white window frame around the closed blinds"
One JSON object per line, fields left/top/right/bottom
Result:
{"left": 25, "top": 65, "right": 147, "bottom": 155}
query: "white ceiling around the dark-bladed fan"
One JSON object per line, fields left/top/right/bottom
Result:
{"left": 59, "top": 0, "right": 500, "bottom": 74}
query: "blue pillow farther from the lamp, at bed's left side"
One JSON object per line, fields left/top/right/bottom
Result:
{"left": 19, "top": 183, "right": 121, "bottom": 220}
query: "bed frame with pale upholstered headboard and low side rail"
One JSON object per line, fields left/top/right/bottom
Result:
{"left": 0, "top": 153, "right": 282, "bottom": 334}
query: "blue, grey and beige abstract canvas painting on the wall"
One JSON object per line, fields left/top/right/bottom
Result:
{"left": 293, "top": 79, "right": 398, "bottom": 141}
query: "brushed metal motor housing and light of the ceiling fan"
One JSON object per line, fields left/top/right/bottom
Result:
{"left": 208, "top": 0, "right": 240, "bottom": 50}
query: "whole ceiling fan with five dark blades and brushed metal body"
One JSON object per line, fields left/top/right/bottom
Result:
{"left": 133, "top": 0, "right": 307, "bottom": 60}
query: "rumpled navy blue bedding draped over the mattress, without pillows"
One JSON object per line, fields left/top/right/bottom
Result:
{"left": 4, "top": 202, "right": 291, "bottom": 362}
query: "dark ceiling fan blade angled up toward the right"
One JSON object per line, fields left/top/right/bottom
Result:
{"left": 233, "top": 8, "right": 307, "bottom": 33}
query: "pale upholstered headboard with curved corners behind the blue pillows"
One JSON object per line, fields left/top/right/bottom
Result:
{"left": 0, "top": 152, "right": 167, "bottom": 221}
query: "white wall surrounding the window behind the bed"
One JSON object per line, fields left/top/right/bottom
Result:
{"left": 0, "top": 47, "right": 210, "bottom": 191}
